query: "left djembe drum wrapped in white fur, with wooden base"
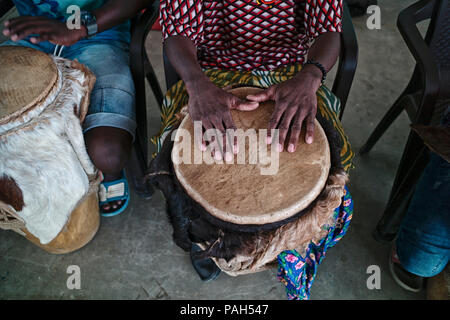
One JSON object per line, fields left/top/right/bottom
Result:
{"left": 0, "top": 46, "right": 100, "bottom": 253}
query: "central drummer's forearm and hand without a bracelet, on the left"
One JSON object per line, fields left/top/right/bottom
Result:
{"left": 164, "top": 35, "right": 259, "bottom": 160}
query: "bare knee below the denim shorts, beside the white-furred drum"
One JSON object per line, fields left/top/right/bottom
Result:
{"left": 86, "top": 128, "right": 131, "bottom": 174}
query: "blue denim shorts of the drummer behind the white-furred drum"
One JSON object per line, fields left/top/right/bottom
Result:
{"left": 1, "top": 37, "right": 136, "bottom": 139}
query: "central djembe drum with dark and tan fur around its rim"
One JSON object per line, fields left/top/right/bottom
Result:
{"left": 147, "top": 87, "right": 347, "bottom": 275}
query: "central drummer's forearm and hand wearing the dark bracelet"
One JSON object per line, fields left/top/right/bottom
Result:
{"left": 247, "top": 32, "right": 340, "bottom": 152}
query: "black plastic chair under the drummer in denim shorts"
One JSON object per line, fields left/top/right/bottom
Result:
{"left": 0, "top": 0, "right": 163, "bottom": 197}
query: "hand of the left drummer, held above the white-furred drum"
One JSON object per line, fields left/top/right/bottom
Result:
{"left": 3, "top": 16, "right": 86, "bottom": 46}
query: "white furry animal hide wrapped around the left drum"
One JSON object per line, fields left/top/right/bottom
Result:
{"left": 0, "top": 57, "right": 96, "bottom": 244}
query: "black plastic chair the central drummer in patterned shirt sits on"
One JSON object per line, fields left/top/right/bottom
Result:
{"left": 163, "top": 1, "right": 358, "bottom": 119}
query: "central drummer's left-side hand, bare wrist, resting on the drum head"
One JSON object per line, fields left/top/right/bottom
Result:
{"left": 186, "top": 78, "right": 259, "bottom": 161}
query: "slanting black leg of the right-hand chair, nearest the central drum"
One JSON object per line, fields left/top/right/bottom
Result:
{"left": 359, "top": 95, "right": 412, "bottom": 155}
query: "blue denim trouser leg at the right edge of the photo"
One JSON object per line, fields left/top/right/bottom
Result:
{"left": 396, "top": 153, "right": 450, "bottom": 277}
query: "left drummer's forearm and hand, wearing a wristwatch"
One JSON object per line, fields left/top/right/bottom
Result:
{"left": 3, "top": 0, "right": 153, "bottom": 46}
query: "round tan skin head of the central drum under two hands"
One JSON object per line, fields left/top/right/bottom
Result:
{"left": 172, "top": 87, "right": 330, "bottom": 225}
